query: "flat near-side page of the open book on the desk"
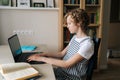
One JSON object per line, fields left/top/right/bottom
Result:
{"left": 4, "top": 67, "right": 39, "bottom": 80}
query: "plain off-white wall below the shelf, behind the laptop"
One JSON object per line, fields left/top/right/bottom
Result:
{"left": 0, "top": 9, "right": 58, "bottom": 52}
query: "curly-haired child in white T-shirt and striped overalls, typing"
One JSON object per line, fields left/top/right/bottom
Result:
{"left": 28, "top": 9, "right": 94, "bottom": 80}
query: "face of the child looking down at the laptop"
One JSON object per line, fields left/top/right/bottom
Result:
{"left": 67, "top": 15, "right": 79, "bottom": 33}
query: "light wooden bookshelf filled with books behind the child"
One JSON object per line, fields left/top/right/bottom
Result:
{"left": 59, "top": 0, "right": 103, "bottom": 70}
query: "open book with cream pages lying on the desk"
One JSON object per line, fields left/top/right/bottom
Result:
{"left": 0, "top": 62, "right": 40, "bottom": 80}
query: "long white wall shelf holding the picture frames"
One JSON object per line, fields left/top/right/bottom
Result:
{"left": 0, "top": 6, "right": 59, "bottom": 10}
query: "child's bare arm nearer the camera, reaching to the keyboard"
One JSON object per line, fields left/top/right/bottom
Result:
{"left": 29, "top": 53, "right": 83, "bottom": 68}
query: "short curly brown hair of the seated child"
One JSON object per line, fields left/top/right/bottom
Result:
{"left": 64, "top": 8, "right": 89, "bottom": 34}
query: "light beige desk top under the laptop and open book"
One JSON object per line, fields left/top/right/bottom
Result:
{"left": 0, "top": 45, "right": 55, "bottom": 80}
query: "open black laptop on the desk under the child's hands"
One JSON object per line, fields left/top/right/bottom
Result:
{"left": 8, "top": 34, "right": 44, "bottom": 64}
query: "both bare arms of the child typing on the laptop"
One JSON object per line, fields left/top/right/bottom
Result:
{"left": 28, "top": 46, "right": 83, "bottom": 68}
